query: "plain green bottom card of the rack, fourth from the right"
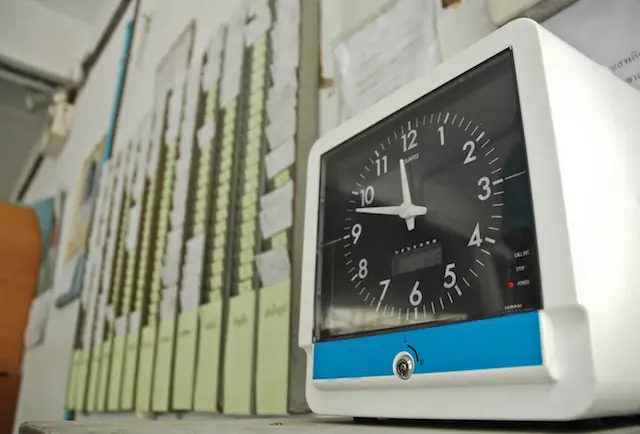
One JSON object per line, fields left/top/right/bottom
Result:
{"left": 173, "top": 309, "right": 198, "bottom": 410}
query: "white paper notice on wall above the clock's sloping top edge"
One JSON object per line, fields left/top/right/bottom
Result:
{"left": 334, "top": 0, "right": 440, "bottom": 119}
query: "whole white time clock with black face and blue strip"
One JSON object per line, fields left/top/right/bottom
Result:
{"left": 299, "top": 20, "right": 640, "bottom": 420}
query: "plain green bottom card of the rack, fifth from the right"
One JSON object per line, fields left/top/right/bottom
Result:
{"left": 151, "top": 319, "right": 176, "bottom": 411}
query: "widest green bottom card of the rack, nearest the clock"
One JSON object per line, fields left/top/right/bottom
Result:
{"left": 256, "top": 280, "right": 291, "bottom": 415}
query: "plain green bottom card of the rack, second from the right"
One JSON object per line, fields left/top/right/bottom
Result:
{"left": 222, "top": 291, "right": 256, "bottom": 415}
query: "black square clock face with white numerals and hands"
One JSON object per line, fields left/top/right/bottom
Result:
{"left": 314, "top": 51, "right": 542, "bottom": 341}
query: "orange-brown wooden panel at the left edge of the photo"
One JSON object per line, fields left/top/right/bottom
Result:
{"left": 0, "top": 203, "right": 42, "bottom": 374}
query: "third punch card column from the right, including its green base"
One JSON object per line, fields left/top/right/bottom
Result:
{"left": 190, "top": 26, "right": 228, "bottom": 412}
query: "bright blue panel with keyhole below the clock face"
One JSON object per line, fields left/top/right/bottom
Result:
{"left": 313, "top": 311, "right": 542, "bottom": 380}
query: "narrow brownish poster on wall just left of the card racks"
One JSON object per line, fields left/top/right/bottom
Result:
{"left": 64, "top": 135, "right": 106, "bottom": 261}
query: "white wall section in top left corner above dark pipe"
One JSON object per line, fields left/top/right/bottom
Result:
{"left": 0, "top": 0, "right": 92, "bottom": 79}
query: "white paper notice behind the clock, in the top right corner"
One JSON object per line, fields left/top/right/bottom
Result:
{"left": 543, "top": 0, "right": 640, "bottom": 89}
